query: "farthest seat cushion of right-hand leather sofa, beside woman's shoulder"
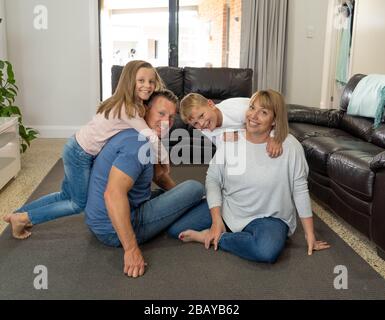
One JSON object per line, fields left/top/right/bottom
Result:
{"left": 289, "top": 122, "right": 351, "bottom": 142}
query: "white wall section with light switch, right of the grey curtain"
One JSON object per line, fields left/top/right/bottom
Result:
{"left": 283, "top": 0, "right": 328, "bottom": 107}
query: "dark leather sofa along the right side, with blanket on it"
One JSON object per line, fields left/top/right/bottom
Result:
{"left": 288, "top": 74, "right": 385, "bottom": 259}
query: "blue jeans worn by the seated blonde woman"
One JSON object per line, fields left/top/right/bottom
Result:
{"left": 169, "top": 201, "right": 289, "bottom": 263}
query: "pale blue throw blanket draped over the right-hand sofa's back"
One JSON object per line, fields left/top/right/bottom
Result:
{"left": 347, "top": 74, "right": 385, "bottom": 128}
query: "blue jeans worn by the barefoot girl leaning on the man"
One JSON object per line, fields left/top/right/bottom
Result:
{"left": 16, "top": 136, "right": 94, "bottom": 224}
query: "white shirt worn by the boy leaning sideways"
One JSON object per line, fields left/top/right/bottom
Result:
{"left": 201, "top": 98, "right": 250, "bottom": 145}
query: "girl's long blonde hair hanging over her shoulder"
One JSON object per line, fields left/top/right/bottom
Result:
{"left": 97, "top": 60, "right": 165, "bottom": 119}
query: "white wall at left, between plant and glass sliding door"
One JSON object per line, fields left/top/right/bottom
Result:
{"left": 5, "top": 0, "right": 100, "bottom": 137}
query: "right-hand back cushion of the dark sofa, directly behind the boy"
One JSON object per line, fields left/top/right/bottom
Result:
{"left": 184, "top": 67, "right": 253, "bottom": 102}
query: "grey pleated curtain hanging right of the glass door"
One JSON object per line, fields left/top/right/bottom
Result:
{"left": 240, "top": 0, "right": 288, "bottom": 92}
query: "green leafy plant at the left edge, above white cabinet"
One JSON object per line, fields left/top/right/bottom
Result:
{"left": 0, "top": 60, "right": 38, "bottom": 152}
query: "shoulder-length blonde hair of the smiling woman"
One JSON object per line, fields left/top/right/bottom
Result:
{"left": 250, "top": 89, "right": 289, "bottom": 143}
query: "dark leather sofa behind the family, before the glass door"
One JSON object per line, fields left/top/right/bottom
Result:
{"left": 111, "top": 66, "right": 253, "bottom": 165}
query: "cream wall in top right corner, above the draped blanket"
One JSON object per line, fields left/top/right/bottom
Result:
{"left": 350, "top": 0, "right": 385, "bottom": 75}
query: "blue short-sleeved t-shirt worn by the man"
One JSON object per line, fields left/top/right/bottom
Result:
{"left": 85, "top": 129, "right": 153, "bottom": 234}
